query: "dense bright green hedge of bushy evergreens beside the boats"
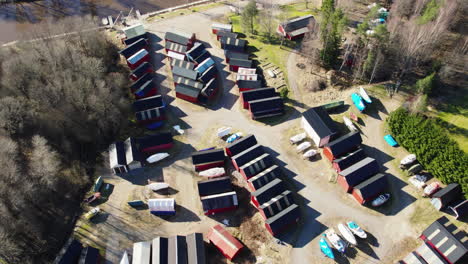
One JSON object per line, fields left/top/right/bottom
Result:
{"left": 387, "top": 108, "right": 468, "bottom": 198}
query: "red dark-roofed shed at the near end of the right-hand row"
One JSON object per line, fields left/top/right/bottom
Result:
{"left": 352, "top": 173, "right": 388, "bottom": 204}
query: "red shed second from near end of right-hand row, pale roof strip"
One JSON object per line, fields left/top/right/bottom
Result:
{"left": 337, "top": 157, "right": 380, "bottom": 193}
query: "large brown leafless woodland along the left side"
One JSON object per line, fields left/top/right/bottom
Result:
{"left": 0, "top": 19, "right": 130, "bottom": 263}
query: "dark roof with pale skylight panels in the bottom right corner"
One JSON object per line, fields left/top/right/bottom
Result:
{"left": 422, "top": 216, "right": 468, "bottom": 263}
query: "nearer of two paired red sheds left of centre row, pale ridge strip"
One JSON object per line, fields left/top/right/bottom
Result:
{"left": 200, "top": 191, "right": 239, "bottom": 215}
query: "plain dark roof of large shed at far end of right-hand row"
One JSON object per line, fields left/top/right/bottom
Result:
{"left": 302, "top": 106, "right": 337, "bottom": 138}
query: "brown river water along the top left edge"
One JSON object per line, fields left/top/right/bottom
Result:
{"left": 0, "top": 0, "right": 195, "bottom": 43}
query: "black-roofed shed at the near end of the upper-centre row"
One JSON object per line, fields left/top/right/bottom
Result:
{"left": 249, "top": 96, "right": 284, "bottom": 120}
